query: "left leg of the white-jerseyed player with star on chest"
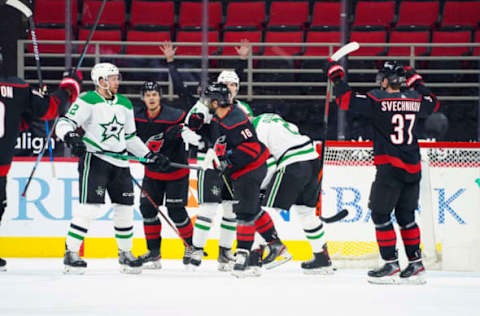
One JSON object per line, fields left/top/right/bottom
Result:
{"left": 63, "top": 153, "right": 106, "bottom": 274}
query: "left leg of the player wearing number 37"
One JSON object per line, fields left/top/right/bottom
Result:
{"left": 368, "top": 167, "right": 402, "bottom": 284}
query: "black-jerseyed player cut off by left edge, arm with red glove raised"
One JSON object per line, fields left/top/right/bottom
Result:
{"left": 0, "top": 47, "right": 81, "bottom": 271}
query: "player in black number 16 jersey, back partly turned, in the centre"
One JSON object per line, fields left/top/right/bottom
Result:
{"left": 202, "top": 83, "right": 291, "bottom": 277}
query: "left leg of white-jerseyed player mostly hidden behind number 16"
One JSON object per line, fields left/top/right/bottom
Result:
{"left": 191, "top": 169, "right": 222, "bottom": 266}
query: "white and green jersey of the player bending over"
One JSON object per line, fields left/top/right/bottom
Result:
{"left": 253, "top": 113, "right": 319, "bottom": 169}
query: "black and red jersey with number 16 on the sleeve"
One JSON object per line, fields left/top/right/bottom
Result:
{"left": 212, "top": 105, "right": 270, "bottom": 179}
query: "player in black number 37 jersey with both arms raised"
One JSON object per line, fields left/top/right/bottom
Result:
{"left": 327, "top": 60, "right": 439, "bottom": 283}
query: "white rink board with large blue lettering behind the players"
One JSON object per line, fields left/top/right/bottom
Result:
{"left": 0, "top": 161, "right": 480, "bottom": 251}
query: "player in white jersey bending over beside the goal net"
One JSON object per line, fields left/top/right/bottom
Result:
{"left": 253, "top": 113, "right": 333, "bottom": 274}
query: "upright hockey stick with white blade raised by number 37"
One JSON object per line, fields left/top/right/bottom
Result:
{"left": 316, "top": 42, "right": 360, "bottom": 222}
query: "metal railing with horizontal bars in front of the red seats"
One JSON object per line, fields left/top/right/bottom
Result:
{"left": 17, "top": 40, "right": 480, "bottom": 102}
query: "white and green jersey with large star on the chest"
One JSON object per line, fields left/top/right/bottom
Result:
{"left": 56, "top": 91, "right": 149, "bottom": 167}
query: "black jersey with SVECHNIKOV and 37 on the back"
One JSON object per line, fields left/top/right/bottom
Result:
{"left": 335, "top": 81, "right": 439, "bottom": 181}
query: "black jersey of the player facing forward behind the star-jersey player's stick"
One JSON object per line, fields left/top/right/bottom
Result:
{"left": 135, "top": 105, "right": 189, "bottom": 180}
